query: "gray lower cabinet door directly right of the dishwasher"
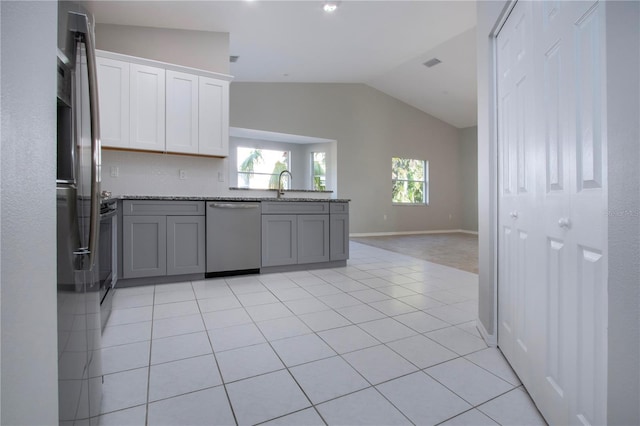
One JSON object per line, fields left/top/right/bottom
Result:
{"left": 262, "top": 214, "right": 298, "bottom": 267}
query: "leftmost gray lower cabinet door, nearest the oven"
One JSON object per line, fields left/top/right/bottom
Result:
{"left": 122, "top": 216, "right": 167, "bottom": 278}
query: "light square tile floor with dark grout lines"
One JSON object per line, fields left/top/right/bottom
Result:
{"left": 100, "top": 242, "right": 545, "bottom": 426}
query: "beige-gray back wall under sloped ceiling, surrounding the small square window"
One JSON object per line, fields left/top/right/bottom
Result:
{"left": 230, "top": 82, "right": 462, "bottom": 234}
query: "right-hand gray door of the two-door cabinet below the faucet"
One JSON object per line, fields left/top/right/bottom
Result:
{"left": 298, "top": 214, "right": 329, "bottom": 263}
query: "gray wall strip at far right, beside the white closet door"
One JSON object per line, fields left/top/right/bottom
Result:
{"left": 605, "top": 1, "right": 640, "bottom": 425}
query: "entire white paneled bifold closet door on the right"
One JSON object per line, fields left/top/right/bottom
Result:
{"left": 497, "top": 1, "right": 607, "bottom": 424}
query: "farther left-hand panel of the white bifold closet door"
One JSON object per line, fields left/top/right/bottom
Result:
{"left": 498, "top": 2, "right": 538, "bottom": 392}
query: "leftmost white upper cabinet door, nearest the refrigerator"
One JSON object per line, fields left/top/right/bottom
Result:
{"left": 97, "top": 57, "right": 130, "bottom": 148}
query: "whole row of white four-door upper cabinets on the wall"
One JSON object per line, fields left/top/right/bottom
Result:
{"left": 98, "top": 51, "right": 231, "bottom": 157}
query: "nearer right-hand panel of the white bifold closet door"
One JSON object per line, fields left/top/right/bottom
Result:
{"left": 536, "top": 1, "right": 607, "bottom": 424}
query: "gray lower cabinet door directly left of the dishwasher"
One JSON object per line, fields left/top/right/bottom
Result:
{"left": 167, "top": 216, "right": 206, "bottom": 275}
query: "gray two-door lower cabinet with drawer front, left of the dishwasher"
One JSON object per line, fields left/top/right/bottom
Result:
{"left": 122, "top": 200, "right": 206, "bottom": 279}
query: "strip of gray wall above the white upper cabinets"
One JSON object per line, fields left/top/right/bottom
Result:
{"left": 96, "top": 24, "right": 229, "bottom": 74}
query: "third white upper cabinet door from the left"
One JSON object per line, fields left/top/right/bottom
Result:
{"left": 166, "top": 70, "right": 198, "bottom": 154}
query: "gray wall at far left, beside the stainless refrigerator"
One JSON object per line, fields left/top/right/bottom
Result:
{"left": 0, "top": 1, "right": 58, "bottom": 425}
